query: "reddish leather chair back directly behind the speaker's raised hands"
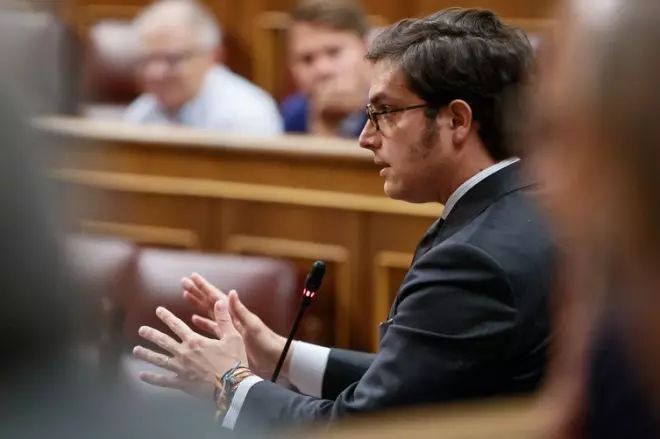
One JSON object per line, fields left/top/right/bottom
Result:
{"left": 124, "top": 249, "right": 300, "bottom": 345}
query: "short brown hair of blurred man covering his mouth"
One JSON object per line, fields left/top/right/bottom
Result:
{"left": 291, "top": 0, "right": 369, "bottom": 37}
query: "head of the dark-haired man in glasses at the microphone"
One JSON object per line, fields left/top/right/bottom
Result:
{"left": 360, "top": 8, "right": 532, "bottom": 203}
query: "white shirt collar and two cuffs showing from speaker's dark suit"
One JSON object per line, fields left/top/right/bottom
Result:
{"left": 222, "top": 157, "right": 520, "bottom": 429}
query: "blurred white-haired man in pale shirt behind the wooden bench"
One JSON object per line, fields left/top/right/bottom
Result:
{"left": 124, "top": 0, "right": 282, "bottom": 135}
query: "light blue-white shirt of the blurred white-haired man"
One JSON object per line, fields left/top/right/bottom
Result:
{"left": 123, "top": 65, "right": 284, "bottom": 135}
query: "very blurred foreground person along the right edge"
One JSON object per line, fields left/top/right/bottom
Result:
{"left": 526, "top": 0, "right": 660, "bottom": 438}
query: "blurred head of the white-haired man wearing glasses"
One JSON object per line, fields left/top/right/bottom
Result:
{"left": 134, "top": 0, "right": 221, "bottom": 111}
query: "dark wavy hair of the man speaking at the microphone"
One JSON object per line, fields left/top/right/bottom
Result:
{"left": 367, "top": 8, "right": 533, "bottom": 160}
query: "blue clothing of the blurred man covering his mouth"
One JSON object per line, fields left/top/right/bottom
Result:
{"left": 280, "top": 93, "right": 367, "bottom": 137}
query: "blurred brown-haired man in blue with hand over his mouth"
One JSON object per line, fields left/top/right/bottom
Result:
{"left": 280, "top": 0, "right": 370, "bottom": 137}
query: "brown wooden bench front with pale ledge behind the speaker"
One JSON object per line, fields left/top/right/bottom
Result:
{"left": 37, "top": 119, "right": 442, "bottom": 350}
